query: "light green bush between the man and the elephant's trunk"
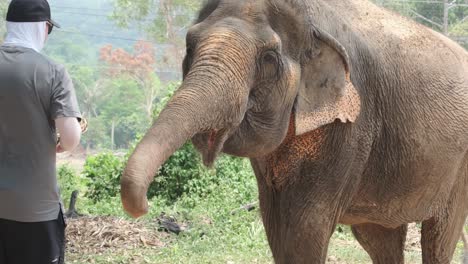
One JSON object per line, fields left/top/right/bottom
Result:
{"left": 83, "top": 153, "right": 125, "bottom": 202}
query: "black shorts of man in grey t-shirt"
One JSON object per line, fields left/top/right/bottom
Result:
{"left": 0, "top": 211, "right": 66, "bottom": 264}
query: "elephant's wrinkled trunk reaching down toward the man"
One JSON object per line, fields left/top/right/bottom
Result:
{"left": 121, "top": 32, "right": 254, "bottom": 217}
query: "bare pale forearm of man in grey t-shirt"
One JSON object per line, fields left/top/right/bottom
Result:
{"left": 55, "top": 117, "right": 81, "bottom": 152}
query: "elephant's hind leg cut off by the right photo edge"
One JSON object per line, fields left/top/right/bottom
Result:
{"left": 421, "top": 168, "right": 468, "bottom": 264}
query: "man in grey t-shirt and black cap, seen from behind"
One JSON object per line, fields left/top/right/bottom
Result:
{"left": 0, "top": 0, "right": 81, "bottom": 264}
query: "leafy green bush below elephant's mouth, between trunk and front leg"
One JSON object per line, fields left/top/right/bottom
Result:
{"left": 125, "top": 137, "right": 253, "bottom": 204}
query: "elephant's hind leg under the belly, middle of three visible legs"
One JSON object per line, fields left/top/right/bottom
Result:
{"left": 351, "top": 224, "right": 408, "bottom": 264}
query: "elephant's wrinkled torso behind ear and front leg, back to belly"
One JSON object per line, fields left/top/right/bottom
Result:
{"left": 326, "top": 0, "right": 468, "bottom": 227}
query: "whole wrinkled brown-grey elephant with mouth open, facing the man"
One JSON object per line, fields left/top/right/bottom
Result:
{"left": 121, "top": 0, "right": 468, "bottom": 264}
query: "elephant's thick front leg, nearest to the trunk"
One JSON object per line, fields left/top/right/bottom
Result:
{"left": 259, "top": 173, "right": 349, "bottom": 264}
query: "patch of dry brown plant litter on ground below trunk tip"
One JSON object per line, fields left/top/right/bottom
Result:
{"left": 66, "top": 217, "right": 165, "bottom": 255}
